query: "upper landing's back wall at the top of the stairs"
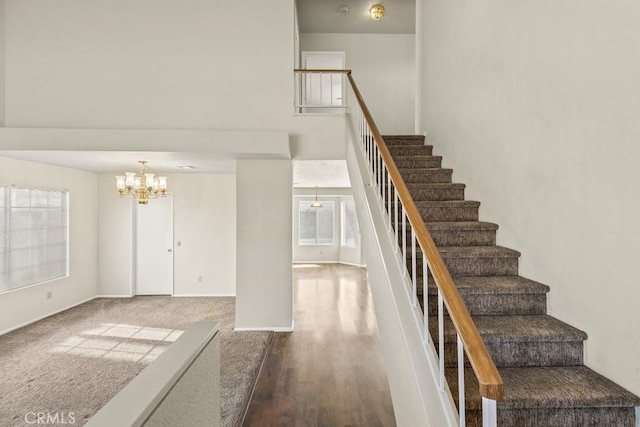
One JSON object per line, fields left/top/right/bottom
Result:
{"left": 300, "top": 33, "right": 416, "bottom": 134}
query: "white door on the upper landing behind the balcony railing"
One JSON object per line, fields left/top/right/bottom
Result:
{"left": 301, "top": 52, "right": 345, "bottom": 112}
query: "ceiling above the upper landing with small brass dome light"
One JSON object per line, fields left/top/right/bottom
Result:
{"left": 297, "top": 0, "right": 416, "bottom": 34}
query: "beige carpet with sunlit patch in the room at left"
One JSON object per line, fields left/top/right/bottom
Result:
{"left": 0, "top": 297, "right": 272, "bottom": 427}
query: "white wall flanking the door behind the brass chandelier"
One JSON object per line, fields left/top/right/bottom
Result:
{"left": 98, "top": 173, "right": 236, "bottom": 296}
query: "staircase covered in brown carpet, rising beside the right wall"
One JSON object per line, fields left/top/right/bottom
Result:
{"left": 384, "top": 136, "right": 640, "bottom": 427}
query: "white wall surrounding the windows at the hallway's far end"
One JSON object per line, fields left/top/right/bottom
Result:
{"left": 293, "top": 192, "right": 363, "bottom": 265}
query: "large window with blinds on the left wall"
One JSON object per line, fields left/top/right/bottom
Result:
{"left": 0, "top": 186, "right": 69, "bottom": 292}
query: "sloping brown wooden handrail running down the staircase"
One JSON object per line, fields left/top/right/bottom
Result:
{"left": 347, "top": 73, "right": 504, "bottom": 400}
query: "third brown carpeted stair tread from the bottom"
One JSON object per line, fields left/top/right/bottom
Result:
{"left": 419, "top": 276, "right": 549, "bottom": 296}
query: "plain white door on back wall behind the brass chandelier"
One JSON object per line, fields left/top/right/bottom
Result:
{"left": 136, "top": 194, "right": 173, "bottom": 295}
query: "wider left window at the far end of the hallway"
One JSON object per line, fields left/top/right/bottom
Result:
{"left": 298, "top": 200, "right": 333, "bottom": 245}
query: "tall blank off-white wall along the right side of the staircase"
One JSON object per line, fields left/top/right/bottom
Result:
{"left": 418, "top": 0, "right": 640, "bottom": 394}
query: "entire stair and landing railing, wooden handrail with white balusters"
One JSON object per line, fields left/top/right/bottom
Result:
{"left": 295, "top": 70, "right": 503, "bottom": 427}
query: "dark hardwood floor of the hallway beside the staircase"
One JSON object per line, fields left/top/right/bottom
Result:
{"left": 244, "top": 264, "right": 396, "bottom": 427}
